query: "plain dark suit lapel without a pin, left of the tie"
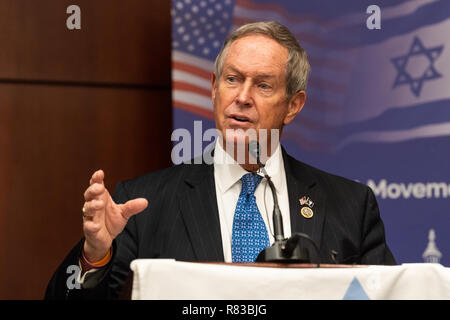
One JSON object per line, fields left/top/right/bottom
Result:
{"left": 179, "top": 164, "right": 224, "bottom": 261}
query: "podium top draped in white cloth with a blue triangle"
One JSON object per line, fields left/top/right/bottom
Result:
{"left": 127, "top": 259, "right": 450, "bottom": 300}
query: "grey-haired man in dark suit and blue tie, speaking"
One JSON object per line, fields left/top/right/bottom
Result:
{"left": 46, "top": 22, "right": 395, "bottom": 298}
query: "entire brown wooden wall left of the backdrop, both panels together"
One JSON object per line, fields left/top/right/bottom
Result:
{"left": 0, "top": 0, "right": 172, "bottom": 299}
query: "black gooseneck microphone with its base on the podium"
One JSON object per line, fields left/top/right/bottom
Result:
{"left": 248, "top": 140, "right": 320, "bottom": 267}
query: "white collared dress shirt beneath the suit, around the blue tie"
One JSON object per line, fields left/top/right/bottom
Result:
{"left": 214, "top": 140, "right": 291, "bottom": 262}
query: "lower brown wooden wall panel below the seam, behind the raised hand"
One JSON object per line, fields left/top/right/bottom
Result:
{"left": 0, "top": 85, "right": 171, "bottom": 298}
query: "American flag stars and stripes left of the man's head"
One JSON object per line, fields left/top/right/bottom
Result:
{"left": 171, "top": 0, "right": 234, "bottom": 119}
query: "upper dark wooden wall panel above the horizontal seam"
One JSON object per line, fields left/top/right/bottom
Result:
{"left": 0, "top": 0, "right": 171, "bottom": 86}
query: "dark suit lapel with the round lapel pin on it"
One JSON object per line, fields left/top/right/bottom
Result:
{"left": 283, "top": 149, "right": 327, "bottom": 252}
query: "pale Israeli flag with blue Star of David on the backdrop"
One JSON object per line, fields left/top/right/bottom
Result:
{"left": 333, "top": 2, "right": 450, "bottom": 149}
